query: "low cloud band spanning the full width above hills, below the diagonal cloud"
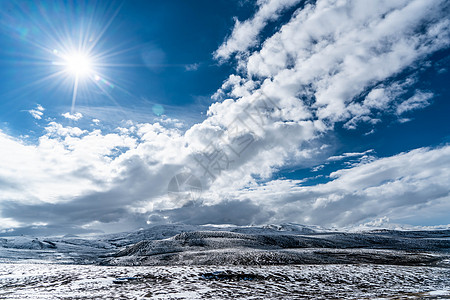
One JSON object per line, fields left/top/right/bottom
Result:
{"left": 0, "top": 120, "right": 450, "bottom": 230}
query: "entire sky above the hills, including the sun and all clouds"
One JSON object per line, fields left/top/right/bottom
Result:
{"left": 0, "top": 0, "right": 450, "bottom": 234}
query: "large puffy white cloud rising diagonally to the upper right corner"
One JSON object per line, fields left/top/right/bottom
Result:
{"left": 201, "top": 0, "right": 450, "bottom": 192}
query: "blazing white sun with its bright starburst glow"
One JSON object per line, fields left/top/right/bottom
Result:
{"left": 40, "top": 0, "right": 125, "bottom": 113}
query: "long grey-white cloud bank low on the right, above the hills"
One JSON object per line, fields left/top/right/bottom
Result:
{"left": 219, "top": 146, "right": 450, "bottom": 226}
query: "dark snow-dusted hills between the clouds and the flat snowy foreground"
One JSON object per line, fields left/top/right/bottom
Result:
{"left": 0, "top": 224, "right": 450, "bottom": 266}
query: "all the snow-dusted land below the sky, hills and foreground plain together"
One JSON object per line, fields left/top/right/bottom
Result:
{"left": 0, "top": 224, "right": 450, "bottom": 299}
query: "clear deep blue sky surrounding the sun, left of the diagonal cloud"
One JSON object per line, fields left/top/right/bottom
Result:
{"left": 1, "top": 1, "right": 243, "bottom": 134}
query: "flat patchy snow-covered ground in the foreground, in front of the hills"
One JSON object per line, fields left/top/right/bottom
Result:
{"left": 0, "top": 264, "right": 450, "bottom": 299}
